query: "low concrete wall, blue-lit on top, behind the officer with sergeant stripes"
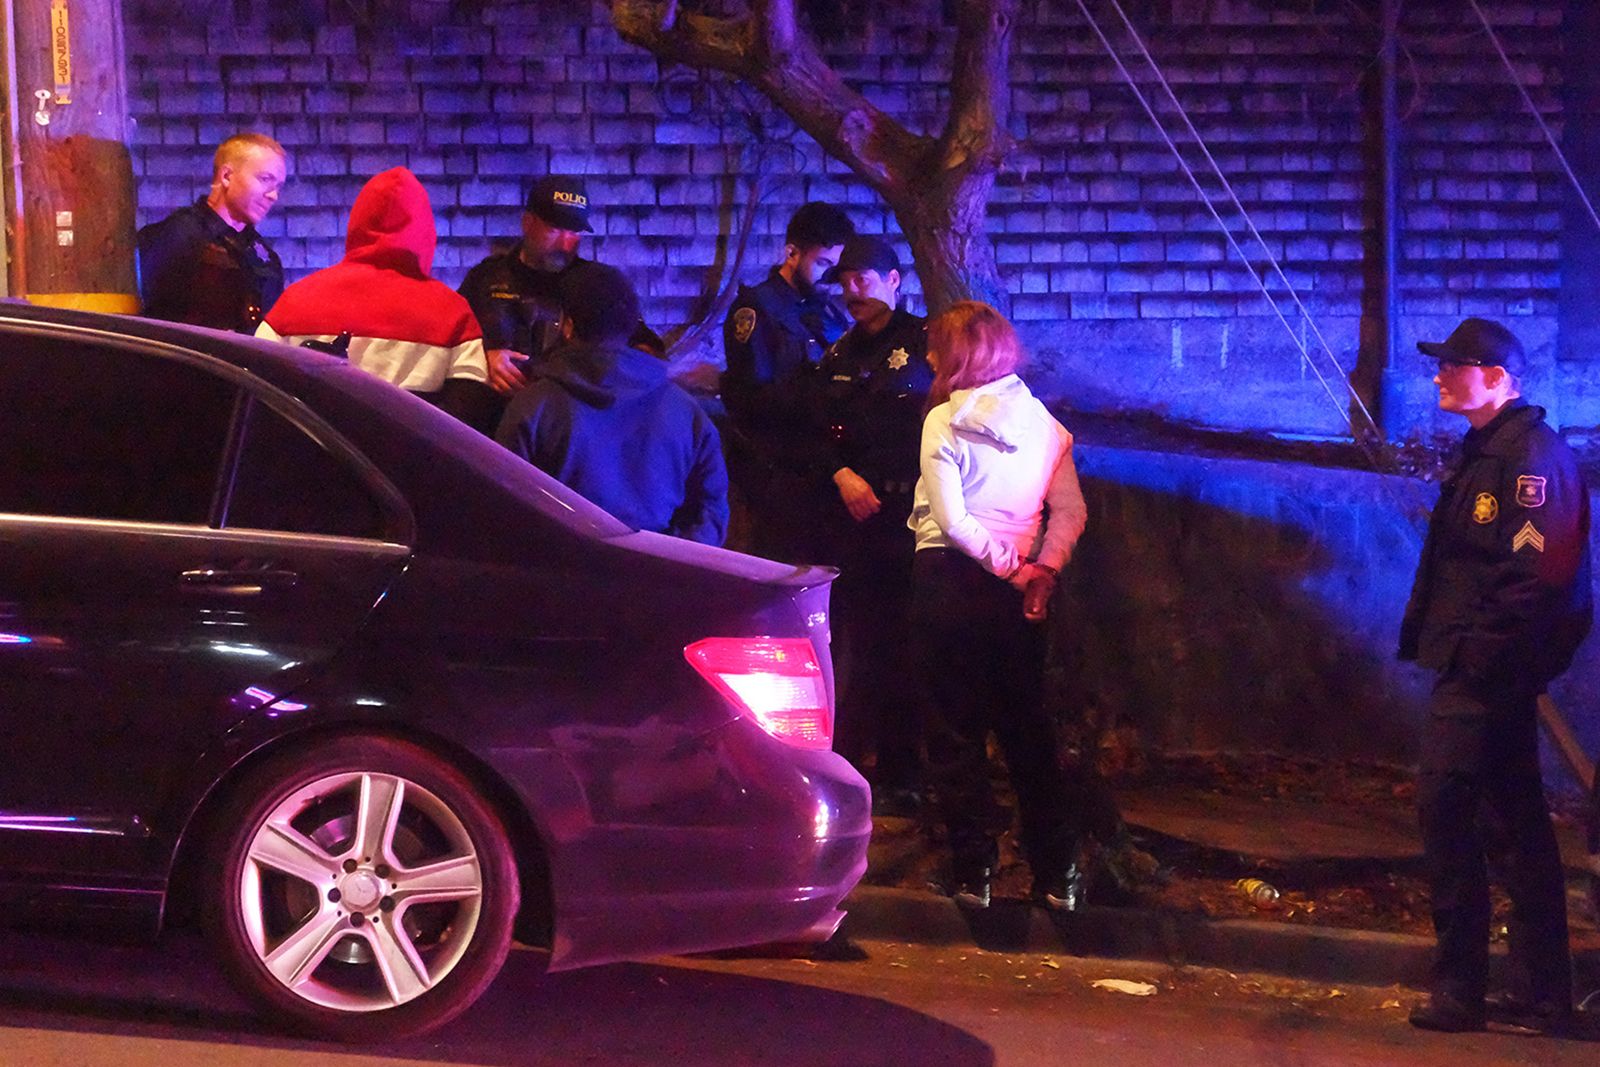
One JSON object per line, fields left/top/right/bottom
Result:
{"left": 1054, "top": 443, "right": 1600, "bottom": 792}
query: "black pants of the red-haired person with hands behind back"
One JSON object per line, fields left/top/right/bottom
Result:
{"left": 912, "top": 549, "right": 1075, "bottom": 878}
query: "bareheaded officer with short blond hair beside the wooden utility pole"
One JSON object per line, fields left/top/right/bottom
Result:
{"left": 139, "top": 133, "right": 288, "bottom": 334}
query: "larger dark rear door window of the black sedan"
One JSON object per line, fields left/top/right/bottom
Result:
{"left": 0, "top": 333, "right": 238, "bottom": 525}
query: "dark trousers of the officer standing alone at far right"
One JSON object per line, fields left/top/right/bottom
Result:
{"left": 1418, "top": 673, "right": 1573, "bottom": 1005}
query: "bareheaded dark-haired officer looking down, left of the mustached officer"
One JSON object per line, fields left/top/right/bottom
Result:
{"left": 722, "top": 203, "right": 856, "bottom": 561}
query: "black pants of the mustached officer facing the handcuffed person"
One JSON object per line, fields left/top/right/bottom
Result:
{"left": 829, "top": 493, "right": 923, "bottom": 790}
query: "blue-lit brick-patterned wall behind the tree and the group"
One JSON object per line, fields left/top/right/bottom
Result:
{"left": 125, "top": 0, "right": 1574, "bottom": 434}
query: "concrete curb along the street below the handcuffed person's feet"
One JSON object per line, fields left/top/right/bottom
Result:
{"left": 842, "top": 886, "right": 1434, "bottom": 985}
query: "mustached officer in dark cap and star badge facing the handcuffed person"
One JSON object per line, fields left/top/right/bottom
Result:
{"left": 818, "top": 237, "right": 933, "bottom": 814}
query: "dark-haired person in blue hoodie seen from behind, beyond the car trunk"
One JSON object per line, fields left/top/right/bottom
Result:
{"left": 496, "top": 262, "right": 728, "bottom": 545}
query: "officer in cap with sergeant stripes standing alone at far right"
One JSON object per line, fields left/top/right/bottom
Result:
{"left": 1400, "top": 318, "right": 1592, "bottom": 1030}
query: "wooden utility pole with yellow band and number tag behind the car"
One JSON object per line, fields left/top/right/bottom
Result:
{"left": 8, "top": 0, "right": 138, "bottom": 312}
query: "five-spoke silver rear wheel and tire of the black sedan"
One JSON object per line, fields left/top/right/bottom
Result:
{"left": 202, "top": 736, "right": 518, "bottom": 1041}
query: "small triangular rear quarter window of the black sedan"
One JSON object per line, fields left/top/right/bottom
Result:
{"left": 222, "top": 400, "right": 384, "bottom": 539}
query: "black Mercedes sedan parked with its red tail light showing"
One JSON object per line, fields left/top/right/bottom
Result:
{"left": 0, "top": 302, "right": 870, "bottom": 1040}
